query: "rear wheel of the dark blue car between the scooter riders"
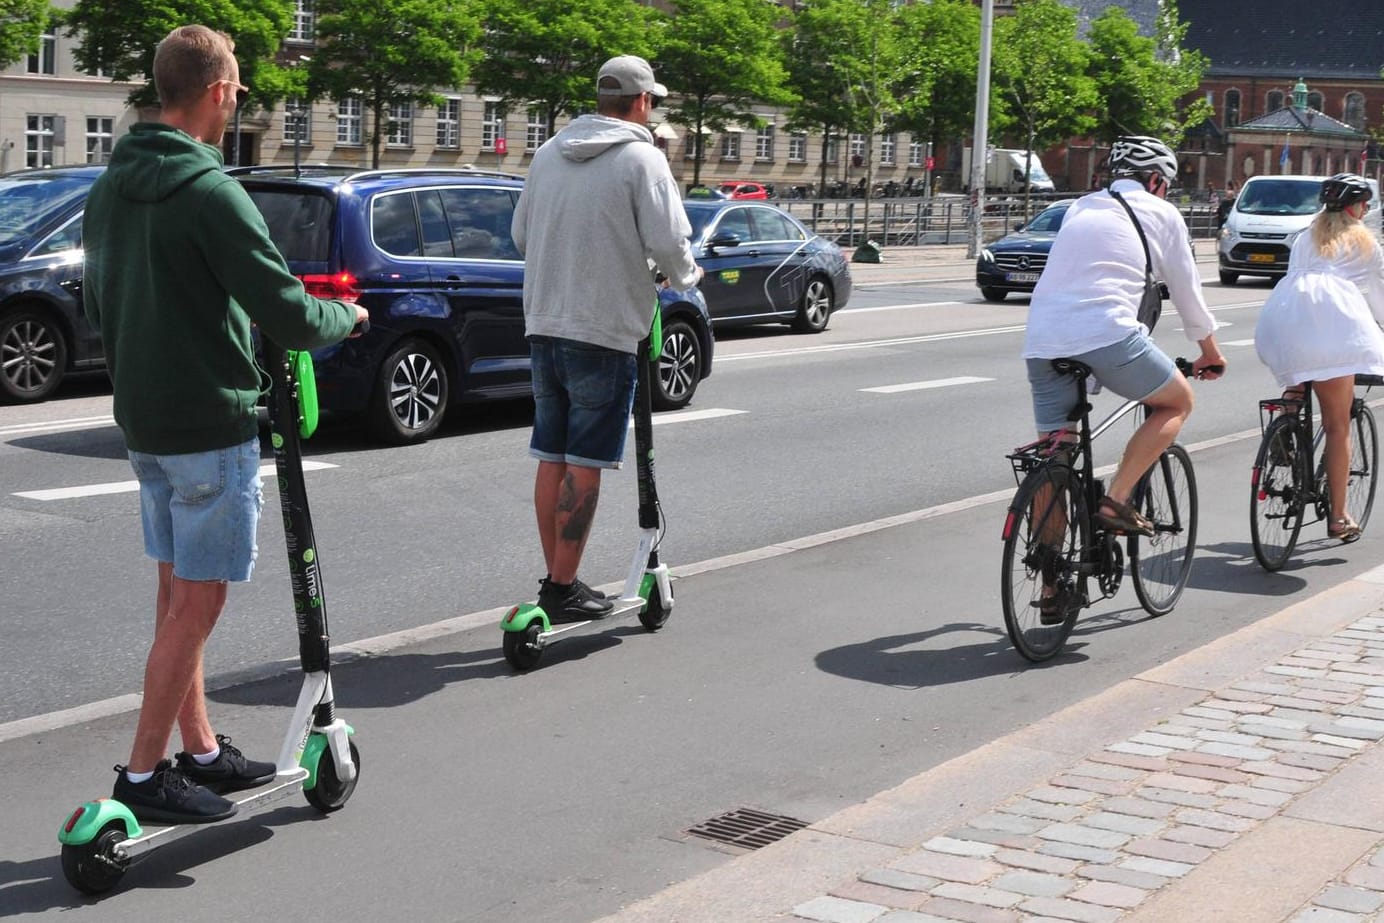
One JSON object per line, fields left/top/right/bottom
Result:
{"left": 368, "top": 338, "right": 448, "bottom": 446}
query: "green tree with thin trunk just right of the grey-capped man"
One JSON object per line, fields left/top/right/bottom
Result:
{"left": 653, "top": 0, "right": 792, "bottom": 183}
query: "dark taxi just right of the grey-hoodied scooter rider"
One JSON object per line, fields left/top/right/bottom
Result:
{"left": 682, "top": 199, "right": 851, "bottom": 333}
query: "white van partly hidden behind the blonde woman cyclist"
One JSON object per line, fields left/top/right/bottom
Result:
{"left": 1217, "top": 174, "right": 1380, "bottom": 285}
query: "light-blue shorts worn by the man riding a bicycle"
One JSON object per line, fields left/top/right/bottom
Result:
{"left": 1027, "top": 329, "right": 1178, "bottom": 433}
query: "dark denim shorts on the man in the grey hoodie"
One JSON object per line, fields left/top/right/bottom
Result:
{"left": 529, "top": 336, "right": 638, "bottom": 468}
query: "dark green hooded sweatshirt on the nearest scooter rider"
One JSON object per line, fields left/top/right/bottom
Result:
{"left": 82, "top": 122, "right": 356, "bottom": 455}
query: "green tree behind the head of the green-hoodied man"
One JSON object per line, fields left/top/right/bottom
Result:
{"left": 63, "top": 0, "right": 295, "bottom": 107}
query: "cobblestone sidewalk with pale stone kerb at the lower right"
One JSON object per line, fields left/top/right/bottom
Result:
{"left": 601, "top": 567, "right": 1384, "bottom": 923}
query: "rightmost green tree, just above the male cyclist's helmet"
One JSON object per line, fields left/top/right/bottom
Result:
{"left": 1086, "top": 4, "right": 1212, "bottom": 148}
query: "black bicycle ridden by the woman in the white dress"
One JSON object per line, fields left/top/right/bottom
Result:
{"left": 1250, "top": 375, "right": 1384, "bottom": 573}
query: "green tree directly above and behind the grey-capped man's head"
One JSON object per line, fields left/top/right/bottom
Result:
{"left": 472, "top": 0, "right": 652, "bottom": 137}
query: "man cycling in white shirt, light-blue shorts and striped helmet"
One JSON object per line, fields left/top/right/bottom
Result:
{"left": 1023, "top": 131, "right": 1225, "bottom": 536}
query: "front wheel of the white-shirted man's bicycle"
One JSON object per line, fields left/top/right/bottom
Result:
{"left": 1129, "top": 444, "right": 1197, "bottom": 616}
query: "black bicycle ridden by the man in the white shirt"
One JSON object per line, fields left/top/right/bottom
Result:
{"left": 1001, "top": 358, "right": 1219, "bottom": 663}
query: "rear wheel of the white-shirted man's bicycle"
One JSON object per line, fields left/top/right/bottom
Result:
{"left": 999, "top": 465, "right": 1089, "bottom": 663}
